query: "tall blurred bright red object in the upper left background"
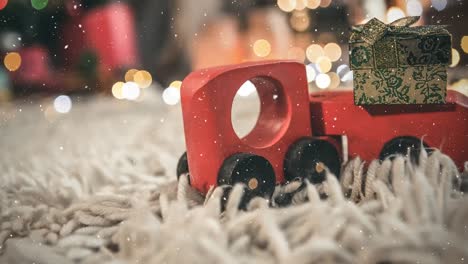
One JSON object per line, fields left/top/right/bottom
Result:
{"left": 63, "top": 2, "right": 138, "bottom": 75}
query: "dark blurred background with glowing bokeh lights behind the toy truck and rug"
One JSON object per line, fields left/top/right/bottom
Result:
{"left": 0, "top": 0, "right": 468, "bottom": 107}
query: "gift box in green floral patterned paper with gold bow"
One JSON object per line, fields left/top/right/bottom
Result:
{"left": 349, "top": 17, "right": 452, "bottom": 105}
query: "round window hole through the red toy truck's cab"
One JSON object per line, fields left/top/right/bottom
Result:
{"left": 231, "top": 76, "right": 289, "bottom": 148}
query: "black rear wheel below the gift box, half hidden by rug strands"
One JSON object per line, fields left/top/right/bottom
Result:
{"left": 379, "top": 137, "right": 432, "bottom": 164}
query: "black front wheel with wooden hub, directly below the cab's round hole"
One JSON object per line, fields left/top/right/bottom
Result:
{"left": 218, "top": 153, "right": 276, "bottom": 208}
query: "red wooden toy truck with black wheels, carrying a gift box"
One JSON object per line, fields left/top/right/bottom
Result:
{"left": 177, "top": 61, "right": 468, "bottom": 200}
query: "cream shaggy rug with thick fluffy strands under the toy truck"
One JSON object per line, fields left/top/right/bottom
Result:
{"left": 0, "top": 91, "right": 468, "bottom": 264}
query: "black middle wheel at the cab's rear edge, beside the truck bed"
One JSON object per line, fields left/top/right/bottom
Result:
{"left": 284, "top": 138, "right": 341, "bottom": 184}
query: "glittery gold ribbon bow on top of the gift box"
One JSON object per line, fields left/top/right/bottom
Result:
{"left": 353, "top": 16, "right": 419, "bottom": 45}
